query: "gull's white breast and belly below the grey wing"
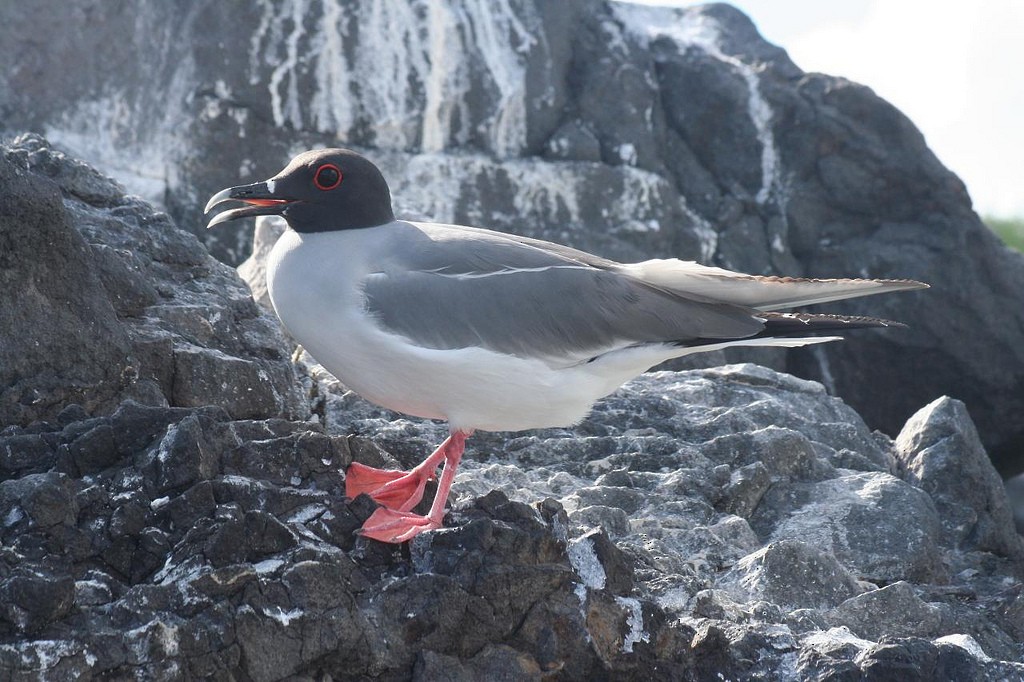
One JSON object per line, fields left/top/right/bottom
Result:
{"left": 267, "top": 225, "right": 617, "bottom": 431}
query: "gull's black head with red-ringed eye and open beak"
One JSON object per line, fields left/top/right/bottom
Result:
{"left": 206, "top": 150, "right": 394, "bottom": 232}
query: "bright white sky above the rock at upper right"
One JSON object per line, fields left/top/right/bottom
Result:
{"left": 647, "top": 0, "right": 1024, "bottom": 217}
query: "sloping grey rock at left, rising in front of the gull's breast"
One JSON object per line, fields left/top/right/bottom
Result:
{"left": 0, "top": 135, "right": 308, "bottom": 421}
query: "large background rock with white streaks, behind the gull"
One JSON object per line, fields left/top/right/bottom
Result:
{"left": 0, "top": 0, "right": 1024, "bottom": 474}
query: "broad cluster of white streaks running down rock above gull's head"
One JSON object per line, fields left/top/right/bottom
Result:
{"left": 249, "top": 0, "right": 537, "bottom": 157}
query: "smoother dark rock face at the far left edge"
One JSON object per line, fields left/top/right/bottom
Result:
{"left": 0, "top": 144, "right": 133, "bottom": 424}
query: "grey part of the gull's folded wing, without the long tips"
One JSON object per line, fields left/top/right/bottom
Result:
{"left": 364, "top": 225, "right": 763, "bottom": 361}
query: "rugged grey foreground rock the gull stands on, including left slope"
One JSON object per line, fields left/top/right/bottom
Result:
{"left": 0, "top": 136, "right": 1024, "bottom": 680}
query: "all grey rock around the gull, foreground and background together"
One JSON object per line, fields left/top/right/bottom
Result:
{"left": 0, "top": 0, "right": 1024, "bottom": 681}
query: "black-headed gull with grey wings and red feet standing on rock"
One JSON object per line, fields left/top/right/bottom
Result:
{"left": 205, "top": 148, "right": 928, "bottom": 544}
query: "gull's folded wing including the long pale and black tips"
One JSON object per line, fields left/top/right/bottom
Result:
{"left": 362, "top": 223, "right": 926, "bottom": 364}
